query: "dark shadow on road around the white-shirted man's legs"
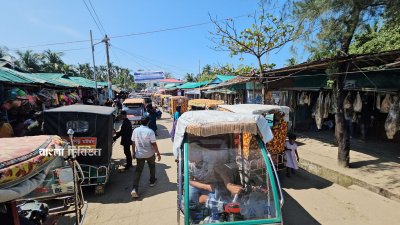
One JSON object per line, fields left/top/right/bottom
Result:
{"left": 83, "top": 163, "right": 177, "bottom": 204}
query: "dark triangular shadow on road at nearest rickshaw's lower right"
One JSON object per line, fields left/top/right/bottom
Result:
{"left": 282, "top": 191, "right": 321, "bottom": 225}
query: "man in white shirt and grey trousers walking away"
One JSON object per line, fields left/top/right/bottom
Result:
{"left": 131, "top": 117, "right": 161, "bottom": 199}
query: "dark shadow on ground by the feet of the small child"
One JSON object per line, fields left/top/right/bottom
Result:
{"left": 278, "top": 169, "right": 333, "bottom": 190}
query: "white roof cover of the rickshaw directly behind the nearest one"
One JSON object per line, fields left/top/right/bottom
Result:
{"left": 218, "top": 104, "right": 290, "bottom": 122}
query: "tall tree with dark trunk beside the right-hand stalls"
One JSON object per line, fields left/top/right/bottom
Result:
{"left": 289, "top": 0, "right": 400, "bottom": 167}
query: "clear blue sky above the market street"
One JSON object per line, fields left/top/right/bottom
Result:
{"left": 0, "top": 0, "right": 301, "bottom": 77}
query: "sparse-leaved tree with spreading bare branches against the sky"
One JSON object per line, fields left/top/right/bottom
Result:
{"left": 211, "top": 0, "right": 296, "bottom": 102}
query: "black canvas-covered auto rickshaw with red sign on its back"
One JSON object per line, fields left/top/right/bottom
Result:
{"left": 43, "top": 105, "right": 114, "bottom": 194}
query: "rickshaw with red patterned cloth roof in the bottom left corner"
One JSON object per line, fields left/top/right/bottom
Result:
{"left": 0, "top": 134, "right": 87, "bottom": 225}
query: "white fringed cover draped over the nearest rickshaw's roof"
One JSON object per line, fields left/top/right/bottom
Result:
{"left": 173, "top": 110, "right": 273, "bottom": 157}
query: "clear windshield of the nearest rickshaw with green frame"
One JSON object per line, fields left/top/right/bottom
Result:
{"left": 183, "top": 134, "right": 280, "bottom": 224}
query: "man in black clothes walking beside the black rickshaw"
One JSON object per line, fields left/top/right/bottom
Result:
{"left": 113, "top": 111, "right": 132, "bottom": 170}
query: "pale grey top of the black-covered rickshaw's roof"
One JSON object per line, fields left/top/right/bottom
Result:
{"left": 44, "top": 104, "right": 115, "bottom": 115}
